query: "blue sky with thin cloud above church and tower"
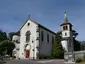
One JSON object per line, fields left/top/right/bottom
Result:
{"left": 0, "top": 0, "right": 85, "bottom": 41}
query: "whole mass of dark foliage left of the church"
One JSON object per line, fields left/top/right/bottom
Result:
{"left": 0, "top": 30, "right": 15, "bottom": 55}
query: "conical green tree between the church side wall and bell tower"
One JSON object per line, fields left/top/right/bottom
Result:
{"left": 52, "top": 32, "right": 64, "bottom": 58}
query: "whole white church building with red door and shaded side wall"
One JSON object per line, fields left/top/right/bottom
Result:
{"left": 12, "top": 19, "right": 55, "bottom": 59}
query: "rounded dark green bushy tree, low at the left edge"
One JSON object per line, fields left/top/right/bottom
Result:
{"left": 0, "top": 40, "right": 15, "bottom": 55}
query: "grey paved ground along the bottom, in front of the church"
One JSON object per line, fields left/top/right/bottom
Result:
{"left": 5, "top": 59, "right": 64, "bottom": 64}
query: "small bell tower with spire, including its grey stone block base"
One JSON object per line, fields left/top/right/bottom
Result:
{"left": 61, "top": 12, "right": 75, "bottom": 64}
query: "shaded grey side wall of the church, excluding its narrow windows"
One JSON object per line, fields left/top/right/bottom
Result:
{"left": 40, "top": 27, "right": 55, "bottom": 56}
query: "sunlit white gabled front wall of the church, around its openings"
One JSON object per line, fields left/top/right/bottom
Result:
{"left": 19, "top": 20, "right": 37, "bottom": 59}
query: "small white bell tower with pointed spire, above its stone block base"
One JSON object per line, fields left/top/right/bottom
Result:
{"left": 61, "top": 12, "right": 73, "bottom": 52}
